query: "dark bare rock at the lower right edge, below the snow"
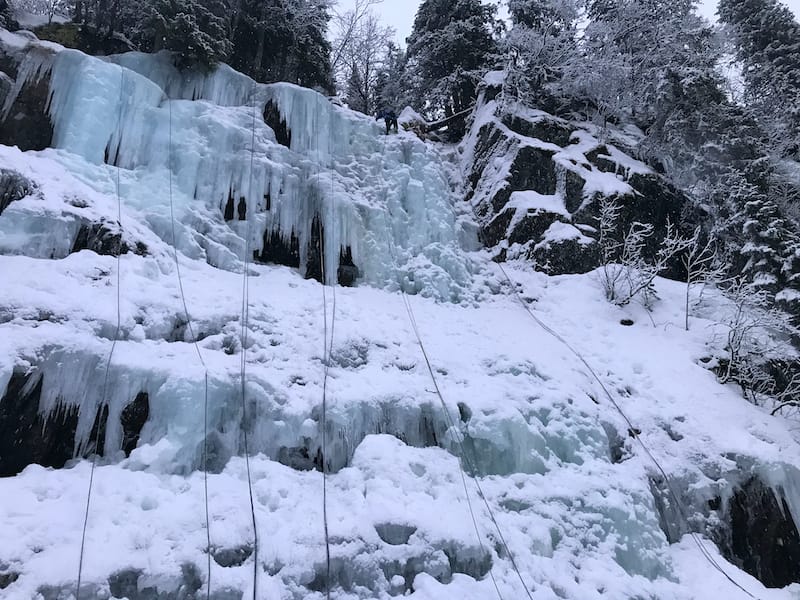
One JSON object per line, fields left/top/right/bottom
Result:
{"left": 721, "top": 477, "right": 800, "bottom": 588}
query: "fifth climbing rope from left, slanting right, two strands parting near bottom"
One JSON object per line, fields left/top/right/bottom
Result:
{"left": 381, "top": 136, "right": 533, "bottom": 600}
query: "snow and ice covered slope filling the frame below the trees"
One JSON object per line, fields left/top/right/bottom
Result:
{"left": 0, "top": 31, "right": 800, "bottom": 600}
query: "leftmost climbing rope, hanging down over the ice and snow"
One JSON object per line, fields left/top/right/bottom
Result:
{"left": 75, "top": 65, "right": 125, "bottom": 600}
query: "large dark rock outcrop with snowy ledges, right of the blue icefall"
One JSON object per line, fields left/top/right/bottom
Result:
{"left": 467, "top": 99, "right": 686, "bottom": 276}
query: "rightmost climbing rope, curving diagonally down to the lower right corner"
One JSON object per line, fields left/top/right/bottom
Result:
{"left": 473, "top": 180, "right": 759, "bottom": 600}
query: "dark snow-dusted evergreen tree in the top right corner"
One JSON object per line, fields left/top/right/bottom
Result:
{"left": 718, "top": 0, "right": 800, "bottom": 158}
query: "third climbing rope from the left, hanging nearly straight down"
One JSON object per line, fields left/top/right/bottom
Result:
{"left": 240, "top": 79, "right": 259, "bottom": 600}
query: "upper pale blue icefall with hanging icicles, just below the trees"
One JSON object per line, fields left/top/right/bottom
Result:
{"left": 9, "top": 45, "right": 471, "bottom": 301}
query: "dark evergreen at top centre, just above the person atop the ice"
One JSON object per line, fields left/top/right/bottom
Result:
{"left": 407, "top": 0, "right": 496, "bottom": 118}
